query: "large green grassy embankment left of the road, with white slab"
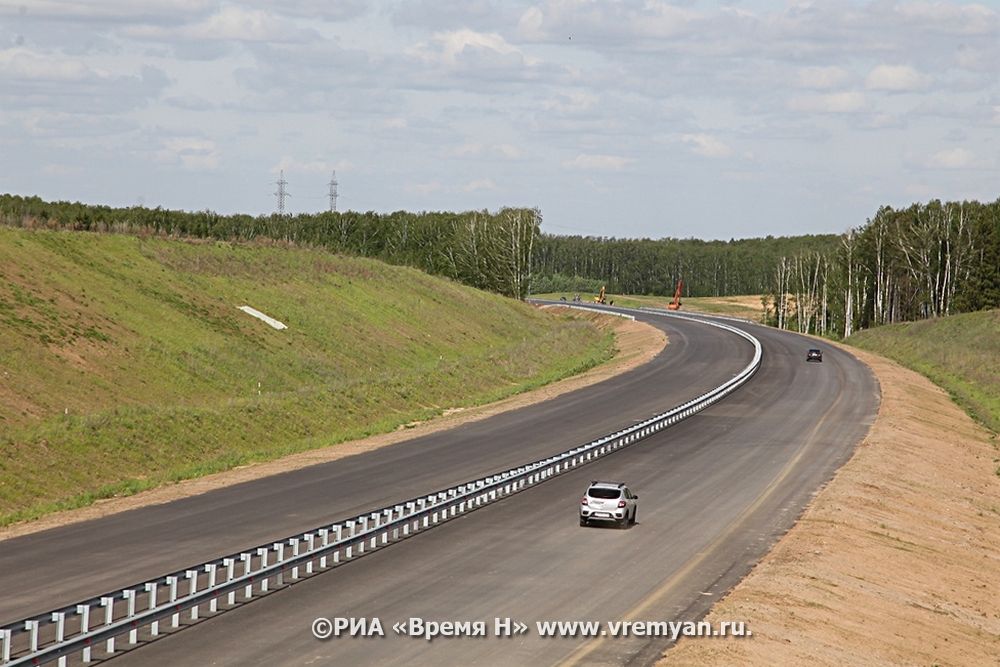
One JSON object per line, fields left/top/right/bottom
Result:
{"left": 0, "top": 228, "right": 613, "bottom": 525}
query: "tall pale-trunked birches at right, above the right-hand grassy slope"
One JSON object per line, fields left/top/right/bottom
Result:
{"left": 763, "top": 199, "right": 1000, "bottom": 337}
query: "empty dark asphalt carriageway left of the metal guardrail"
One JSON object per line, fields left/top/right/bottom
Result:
{"left": 0, "top": 308, "right": 751, "bottom": 624}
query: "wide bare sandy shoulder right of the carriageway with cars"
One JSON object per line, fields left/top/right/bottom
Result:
{"left": 659, "top": 348, "right": 1000, "bottom": 666}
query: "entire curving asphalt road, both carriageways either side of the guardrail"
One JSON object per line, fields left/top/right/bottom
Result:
{"left": 0, "top": 316, "right": 878, "bottom": 665}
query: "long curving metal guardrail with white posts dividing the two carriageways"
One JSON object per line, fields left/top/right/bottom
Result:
{"left": 0, "top": 313, "right": 762, "bottom": 667}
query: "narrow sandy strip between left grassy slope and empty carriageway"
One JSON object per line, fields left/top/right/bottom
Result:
{"left": 0, "top": 311, "right": 667, "bottom": 541}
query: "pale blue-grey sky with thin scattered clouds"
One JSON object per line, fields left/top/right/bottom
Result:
{"left": 0, "top": 0, "right": 1000, "bottom": 239}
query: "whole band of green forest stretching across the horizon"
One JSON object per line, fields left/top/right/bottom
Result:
{"left": 0, "top": 195, "right": 1000, "bottom": 337}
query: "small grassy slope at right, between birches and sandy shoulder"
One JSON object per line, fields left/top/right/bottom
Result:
{"left": 846, "top": 310, "right": 1000, "bottom": 433}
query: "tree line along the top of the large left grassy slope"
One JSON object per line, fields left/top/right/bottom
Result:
{"left": 0, "top": 194, "right": 541, "bottom": 299}
